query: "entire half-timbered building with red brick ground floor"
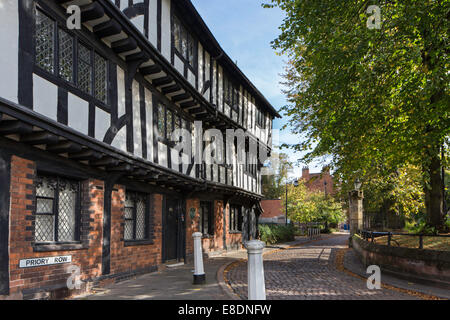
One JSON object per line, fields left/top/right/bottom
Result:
{"left": 0, "top": 0, "right": 279, "bottom": 299}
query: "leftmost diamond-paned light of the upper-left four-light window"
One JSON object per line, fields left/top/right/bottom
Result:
{"left": 35, "top": 11, "right": 55, "bottom": 73}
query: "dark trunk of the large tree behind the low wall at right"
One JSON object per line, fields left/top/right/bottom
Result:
{"left": 425, "top": 147, "right": 444, "bottom": 230}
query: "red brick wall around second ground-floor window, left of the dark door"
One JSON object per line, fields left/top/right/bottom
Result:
{"left": 111, "top": 190, "right": 163, "bottom": 274}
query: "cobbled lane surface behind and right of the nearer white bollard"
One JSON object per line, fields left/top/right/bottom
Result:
{"left": 226, "top": 235, "right": 419, "bottom": 300}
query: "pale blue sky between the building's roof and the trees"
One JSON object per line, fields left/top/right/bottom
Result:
{"left": 191, "top": 0, "right": 322, "bottom": 177}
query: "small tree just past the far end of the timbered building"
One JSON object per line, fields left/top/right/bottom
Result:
{"left": 262, "top": 153, "right": 292, "bottom": 199}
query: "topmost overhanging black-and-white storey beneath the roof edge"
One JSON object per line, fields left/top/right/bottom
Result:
{"left": 53, "top": 0, "right": 279, "bottom": 147}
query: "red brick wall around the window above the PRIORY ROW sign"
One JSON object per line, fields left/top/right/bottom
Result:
{"left": 10, "top": 156, "right": 103, "bottom": 297}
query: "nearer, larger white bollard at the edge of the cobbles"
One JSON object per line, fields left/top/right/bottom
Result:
{"left": 247, "top": 240, "right": 266, "bottom": 300}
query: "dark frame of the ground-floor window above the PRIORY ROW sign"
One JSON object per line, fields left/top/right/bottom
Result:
{"left": 33, "top": 173, "right": 81, "bottom": 247}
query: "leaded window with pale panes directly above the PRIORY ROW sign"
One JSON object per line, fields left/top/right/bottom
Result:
{"left": 34, "top": 176, "right": 80, "bottom": 243}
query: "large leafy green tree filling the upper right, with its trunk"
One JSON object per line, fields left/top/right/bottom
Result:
{"left": 264, "top": 0, "right": 450, "bottom": 228}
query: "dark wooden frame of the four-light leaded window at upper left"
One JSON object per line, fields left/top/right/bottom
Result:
{"left": 32, "top": 4, "right": 111, "bottom": 112}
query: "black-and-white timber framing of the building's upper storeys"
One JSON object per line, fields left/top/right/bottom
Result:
{"left": 0, "top": 0, "right": 279, "bottom": 276}
